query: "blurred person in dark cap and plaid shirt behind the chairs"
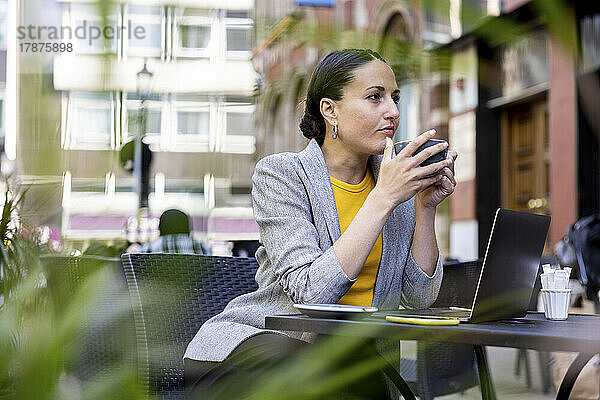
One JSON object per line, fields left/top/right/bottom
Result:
{"left": 139, "top": 208, "right": 210, "bottom": 255}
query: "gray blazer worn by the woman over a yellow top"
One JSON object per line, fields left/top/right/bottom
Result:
{"left": 184, "top": 139, "right": 442, "bottom": 361}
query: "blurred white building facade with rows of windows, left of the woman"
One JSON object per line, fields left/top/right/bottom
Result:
{"left": 9, "top": 0, "right": 258, "bottom": 250}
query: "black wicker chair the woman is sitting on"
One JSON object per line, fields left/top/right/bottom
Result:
{"left": 121, "top": 253, "right": 258, "bottom": 399}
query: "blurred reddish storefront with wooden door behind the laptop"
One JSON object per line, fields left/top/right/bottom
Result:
{"left": 445, "top": 1, "right": 600, "bottom": 255}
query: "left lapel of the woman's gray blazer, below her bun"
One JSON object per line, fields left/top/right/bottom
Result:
{"left": 298, "top": 139, "right": 342, "bottom": 243}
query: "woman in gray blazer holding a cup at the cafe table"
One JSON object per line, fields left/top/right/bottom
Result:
{"left": 185, "top": 49, "right": 457, "bottom": 398}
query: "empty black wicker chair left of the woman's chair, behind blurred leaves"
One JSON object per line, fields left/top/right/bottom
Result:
{"left": 41, "top": 255, "right": 136, "bottom": 385}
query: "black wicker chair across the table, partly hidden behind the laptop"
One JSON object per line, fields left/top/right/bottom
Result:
{"left": 400, "top": 261, "right": 482, "bottom": 400}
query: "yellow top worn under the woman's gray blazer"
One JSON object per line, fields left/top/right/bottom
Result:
{"left": 330, "top": 170, "right": 383, "bottom": 307}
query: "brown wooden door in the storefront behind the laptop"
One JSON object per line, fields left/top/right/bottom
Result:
{"left": 502, "top": 98, "right": 551, "bottom": 250}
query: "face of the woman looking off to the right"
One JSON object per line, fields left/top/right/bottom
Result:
{"left": 335, "top": 60, "right": 400, "bottom": 155}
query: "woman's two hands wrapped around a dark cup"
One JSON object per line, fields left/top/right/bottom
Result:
{"left": 373, "top": 130, "right": 456, "bottom": 211}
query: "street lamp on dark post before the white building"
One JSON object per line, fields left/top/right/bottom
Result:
{"left": 133, "top": 60, "right": 153, "bottom": 240}
